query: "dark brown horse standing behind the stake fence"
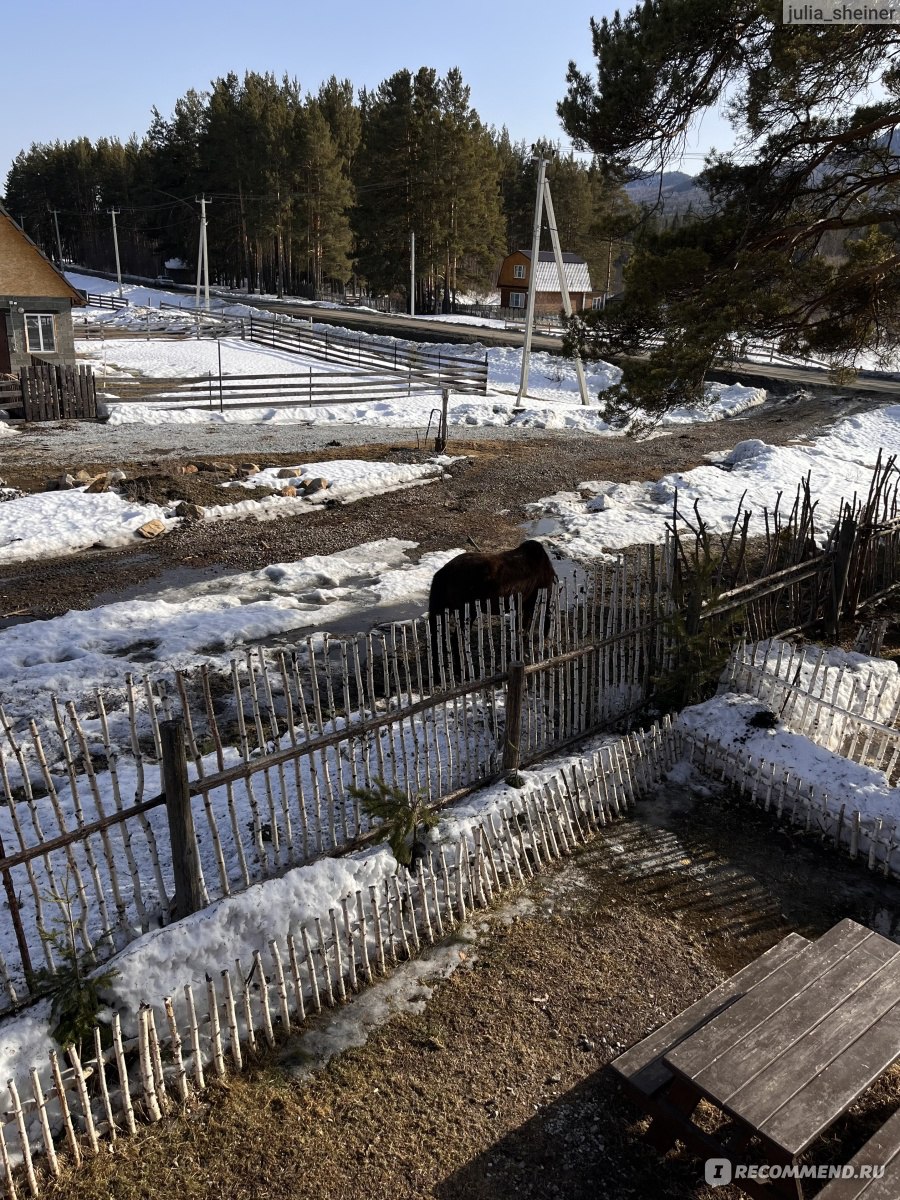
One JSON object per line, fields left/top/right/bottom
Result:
{"left": 428, "top": 540, "right": 557, "bottom": 662}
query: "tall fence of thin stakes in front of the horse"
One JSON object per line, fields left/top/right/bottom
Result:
{"left": 0, "top": 467, "right": 898, "bottom": 1009}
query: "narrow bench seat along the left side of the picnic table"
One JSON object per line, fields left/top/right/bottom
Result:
{"left": 612, "top": 934, "right": 810, "bottom": 1094}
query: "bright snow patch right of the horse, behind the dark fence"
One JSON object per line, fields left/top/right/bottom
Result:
{"left": 528, "top": 406, "right": 900, "bottom": 558}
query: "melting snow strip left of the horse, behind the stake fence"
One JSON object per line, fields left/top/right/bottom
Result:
{"left": 0, "top": 537, "right": 460, "bottom": 727}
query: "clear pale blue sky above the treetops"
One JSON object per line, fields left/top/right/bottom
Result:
{"left": 0, "top": 0, "right": 730, "bottom": 187}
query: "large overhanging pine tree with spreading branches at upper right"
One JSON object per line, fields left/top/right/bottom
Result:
{"left": 558, "top": 0, "right": 900, "bottom": 412}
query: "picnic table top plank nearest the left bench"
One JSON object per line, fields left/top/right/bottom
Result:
{"left": 666, "top": 920, "right": 896, "bottom": 1079}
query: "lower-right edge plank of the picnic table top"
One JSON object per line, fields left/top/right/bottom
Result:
{"left": 763, "top": 998, "right": 900, "bottom": 1163}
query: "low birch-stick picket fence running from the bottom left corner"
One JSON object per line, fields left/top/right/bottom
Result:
{"left": 0, "top": 720, "right": 677, "bottom": 1200}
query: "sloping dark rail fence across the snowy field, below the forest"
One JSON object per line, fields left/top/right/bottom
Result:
{"left": 245, "top": 316, "right": 487, "bottom": 396}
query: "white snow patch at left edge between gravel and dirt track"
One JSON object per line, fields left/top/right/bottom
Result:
{"left": 0, "top": 488, "right": 174, "bottom": 563}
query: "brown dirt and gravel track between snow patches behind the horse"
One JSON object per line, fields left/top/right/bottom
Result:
{"left": 0, "top": 395, "right": 883, "bottom": 619}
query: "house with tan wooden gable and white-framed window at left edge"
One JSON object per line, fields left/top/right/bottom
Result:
{"left": 0, "top": 208, "right": 88, "bottom": 376}
